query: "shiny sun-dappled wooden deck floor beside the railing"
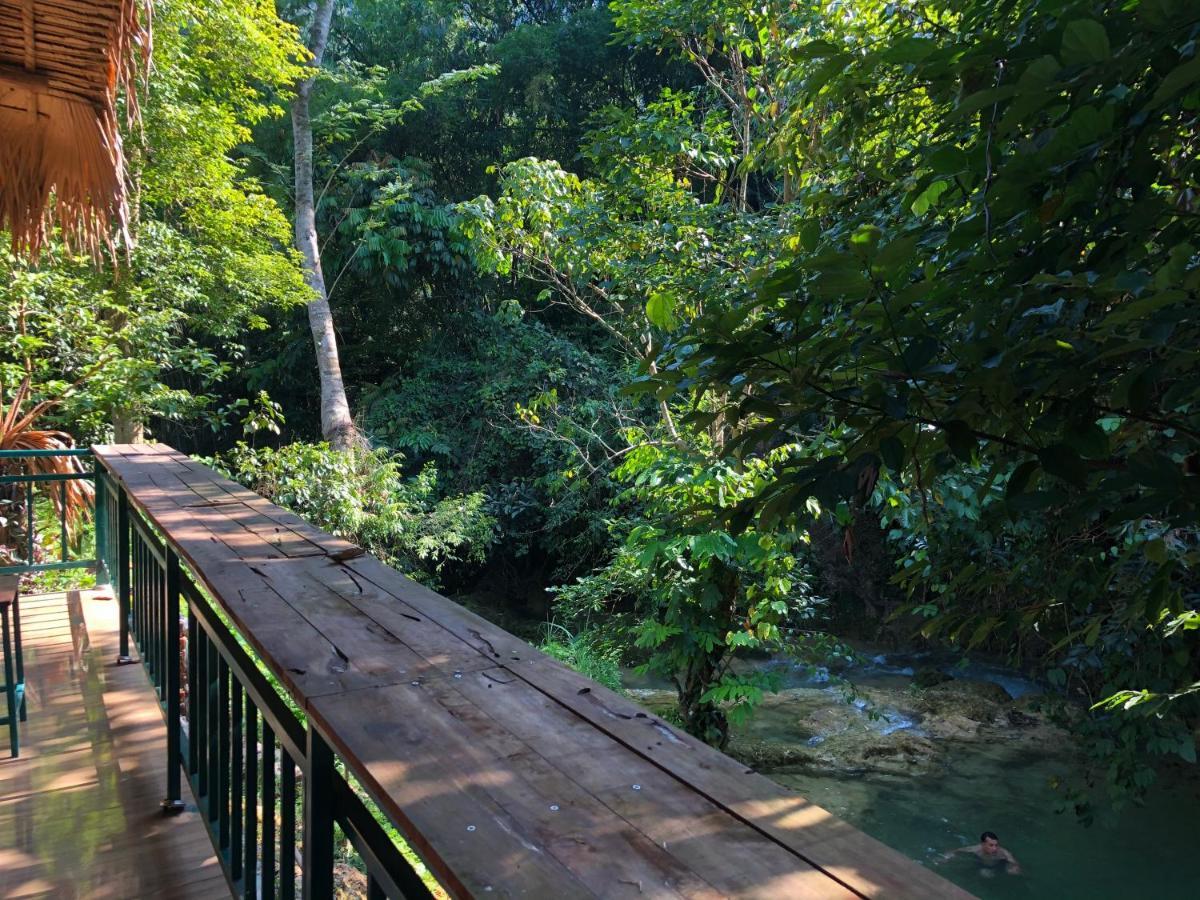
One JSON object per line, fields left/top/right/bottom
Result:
{"left": 0, "top": 592, "right": 229, "bottom": 900}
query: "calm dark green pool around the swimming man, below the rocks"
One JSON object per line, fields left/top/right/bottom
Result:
{"left": 773, "top": 745, "right": 1200, "bottom": 900}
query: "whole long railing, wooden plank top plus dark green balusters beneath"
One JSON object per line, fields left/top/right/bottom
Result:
{"left": 88, "top": 445, "right": 967, "bottom": 899}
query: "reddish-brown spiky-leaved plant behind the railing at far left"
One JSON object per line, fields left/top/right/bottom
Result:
{"left": 0, "top": 378, "right": 96, "bottom": 564}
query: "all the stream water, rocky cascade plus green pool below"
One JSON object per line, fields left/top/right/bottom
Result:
{"left": 631, "top": 656, "right": 1200, "bottom": 900}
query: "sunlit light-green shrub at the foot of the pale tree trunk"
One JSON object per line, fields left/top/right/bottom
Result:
{"left": 217, "top": 443, "right": 496, "bottom": 584}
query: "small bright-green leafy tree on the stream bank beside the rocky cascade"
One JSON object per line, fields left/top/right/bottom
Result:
{"left": 553, "top": 441, "right": 817, "bottom": 746}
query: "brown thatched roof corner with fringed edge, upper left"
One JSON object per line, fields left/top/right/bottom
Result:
{"left": 0, "top": 0, "right": 150, "bottom": 256}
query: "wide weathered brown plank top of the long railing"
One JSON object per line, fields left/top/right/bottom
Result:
{"left": 94, "top": 444, "right": 970, "bottom": 898}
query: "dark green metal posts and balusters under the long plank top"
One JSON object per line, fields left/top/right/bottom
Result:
{"left": 96, "top": 466, "right": 432, "bottom": 900}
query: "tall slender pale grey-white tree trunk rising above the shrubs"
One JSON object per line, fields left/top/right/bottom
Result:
{"left": 292, "top": 0, "right": 358, "bottom": 450}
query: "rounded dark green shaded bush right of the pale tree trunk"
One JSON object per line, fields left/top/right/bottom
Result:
{"left": 361, "top": 305, "right": 636, "bottom": 584}
